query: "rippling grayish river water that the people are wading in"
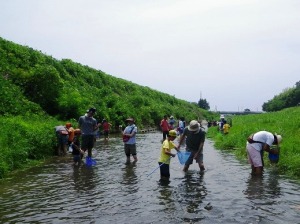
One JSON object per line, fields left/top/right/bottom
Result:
{"left": 0, "top": 133, "right": 300, "bottom": 224}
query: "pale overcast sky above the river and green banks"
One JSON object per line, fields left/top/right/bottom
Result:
{"left": 0, "top": 0, "right": 300, "bottom": 111}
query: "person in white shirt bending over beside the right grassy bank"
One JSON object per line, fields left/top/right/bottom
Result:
{"left": 246, "top": 131, "right": 282, "bottom": 175}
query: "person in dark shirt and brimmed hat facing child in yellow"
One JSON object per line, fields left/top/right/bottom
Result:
{"left": 178, "top": 120, "right": 205, "bottom": 172}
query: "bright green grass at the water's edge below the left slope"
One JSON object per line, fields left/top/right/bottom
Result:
{"left": 0, "top": 115, "right": 58, "bottom": 179}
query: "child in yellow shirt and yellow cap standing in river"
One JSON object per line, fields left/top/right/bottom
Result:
{"left": 158, "top": 130, "right": 178, "bottom": 181}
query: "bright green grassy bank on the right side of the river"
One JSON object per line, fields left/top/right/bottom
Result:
{"left": 207, "top": 107, "right": 300, "bottom": 178}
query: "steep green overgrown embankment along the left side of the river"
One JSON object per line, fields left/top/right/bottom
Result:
{"left": 0, "top": 38, "right": 214, "bottom": 178}
